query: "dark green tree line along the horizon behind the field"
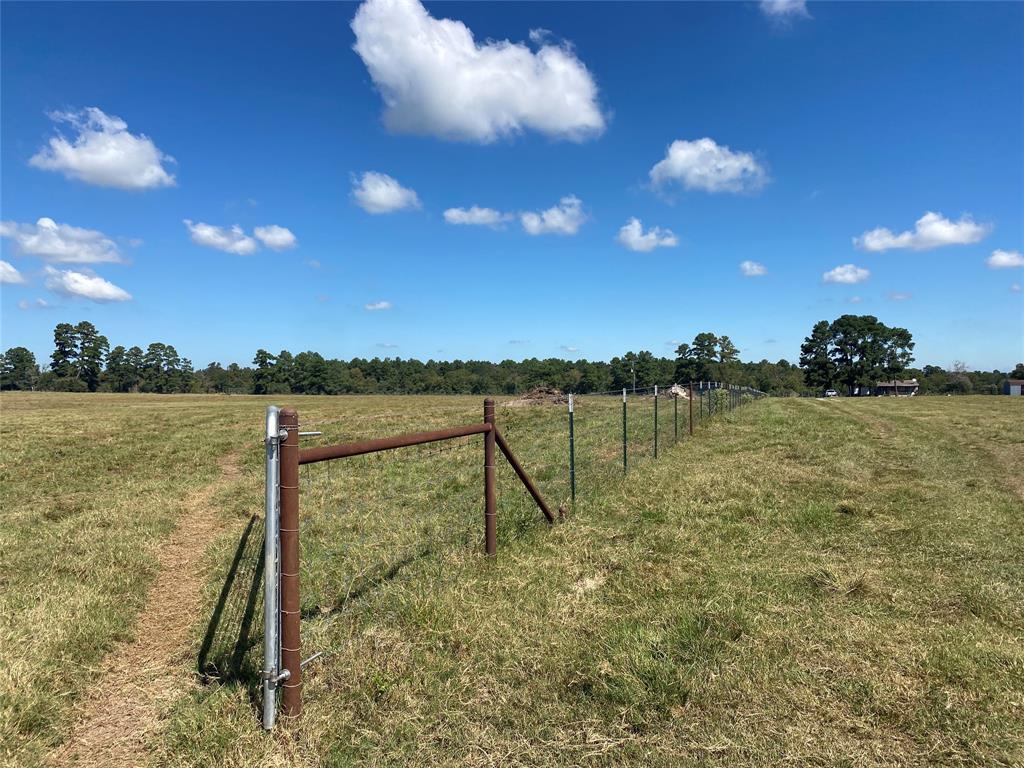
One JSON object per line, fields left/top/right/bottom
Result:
{"left": 0, "top": 315, "right": 1024, "bottom": 395}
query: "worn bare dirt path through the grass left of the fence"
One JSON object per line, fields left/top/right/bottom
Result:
{"left": 49, "top": 454, "right": 241, "bottom": 768}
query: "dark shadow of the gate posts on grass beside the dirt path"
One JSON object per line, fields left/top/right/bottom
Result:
{"left": 197, "top": 515, "right": 264, "bottom": 701}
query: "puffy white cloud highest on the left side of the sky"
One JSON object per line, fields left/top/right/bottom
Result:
{"left": 29, "top": 106, "right": 175, "bottom": 189}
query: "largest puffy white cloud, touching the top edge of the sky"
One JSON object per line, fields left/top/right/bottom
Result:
{"left": 352, "top": 0, "right": 604, "bottom": 142}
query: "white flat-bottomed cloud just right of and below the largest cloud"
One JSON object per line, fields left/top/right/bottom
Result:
{"left": 650, "top": 138, "right": 768, "bottom": 193}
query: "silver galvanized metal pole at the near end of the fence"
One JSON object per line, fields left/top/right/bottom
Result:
{"left": 263, "top": 406, "right": 281, "bottom": 730}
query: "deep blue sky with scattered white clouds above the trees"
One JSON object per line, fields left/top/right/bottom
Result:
{"left": 0, "top": 0, "right": 1024, "bottom": 370}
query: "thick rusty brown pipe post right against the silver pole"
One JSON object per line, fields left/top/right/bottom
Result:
{"left": 279, "top": 408, "right": 302, "bottom": 717}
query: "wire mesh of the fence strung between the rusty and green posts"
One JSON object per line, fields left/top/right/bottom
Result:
{"left": 292, "top": 382, "right": 764, "bottom": 617}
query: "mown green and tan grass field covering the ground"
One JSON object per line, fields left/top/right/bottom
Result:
{"left": 0, "top": 393, "right": 1024, "bottom": 766}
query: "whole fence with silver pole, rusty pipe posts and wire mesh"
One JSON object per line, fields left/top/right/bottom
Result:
{"left": 262, "top": 382, "right": 765, "bottom": 729}
